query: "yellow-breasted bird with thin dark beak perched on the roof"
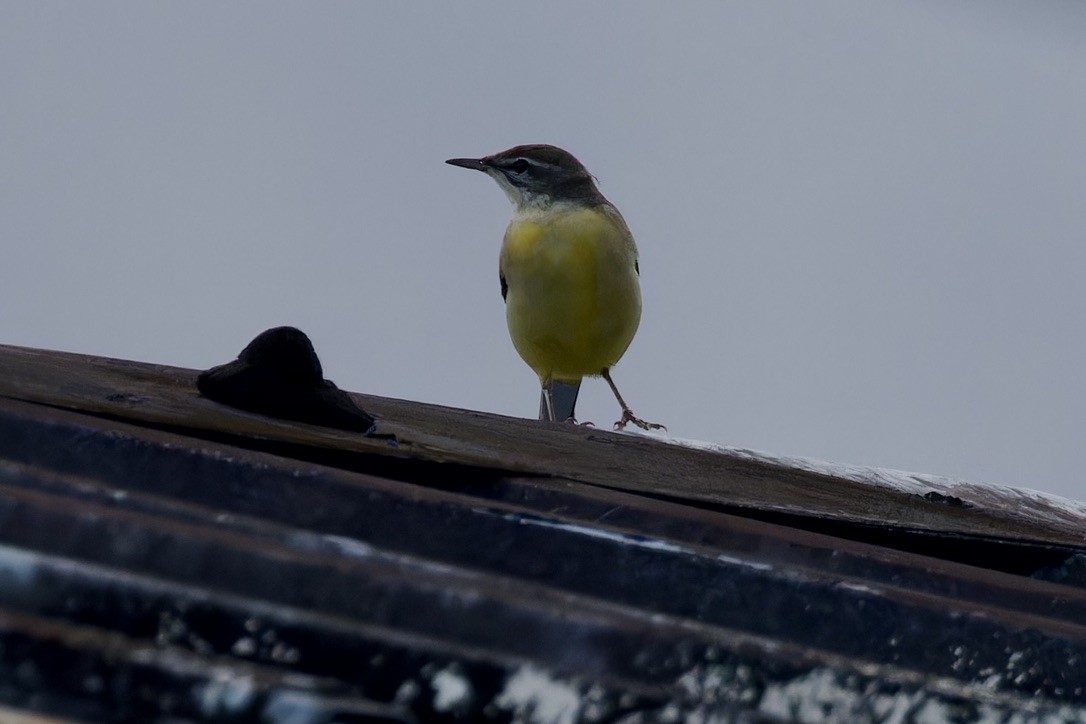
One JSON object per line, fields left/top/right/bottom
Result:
{"left": 445, "top": 143, "right": 666, "bottom": 430}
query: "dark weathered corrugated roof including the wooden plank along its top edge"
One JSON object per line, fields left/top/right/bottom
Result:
{"left": 0, "top": 347, "right": 1086, "bottom": 722}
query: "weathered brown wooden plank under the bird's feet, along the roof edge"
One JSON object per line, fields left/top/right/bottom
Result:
{"left": 0, "top": 346, "right": 1086, "bottom": 547}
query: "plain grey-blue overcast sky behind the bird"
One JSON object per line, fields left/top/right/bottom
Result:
{"left": 0, "top": 0, "right": 1086, "bottom": 500}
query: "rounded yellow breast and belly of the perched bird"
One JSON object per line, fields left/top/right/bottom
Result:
{"left": 501, "top": 206, "right": 641, "bottom": 381}
